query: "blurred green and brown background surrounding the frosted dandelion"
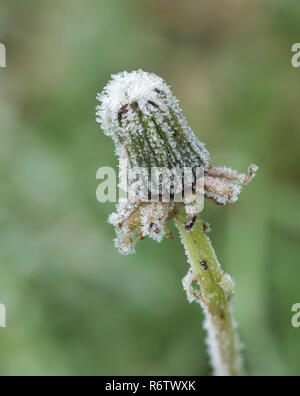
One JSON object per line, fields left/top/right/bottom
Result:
{"left": 0, "top": 0, "right": 300, "bottom": 376}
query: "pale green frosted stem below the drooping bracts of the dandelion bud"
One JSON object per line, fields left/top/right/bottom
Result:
{"left": 175, "top": 209, "right": 244, "bottom": 376}
